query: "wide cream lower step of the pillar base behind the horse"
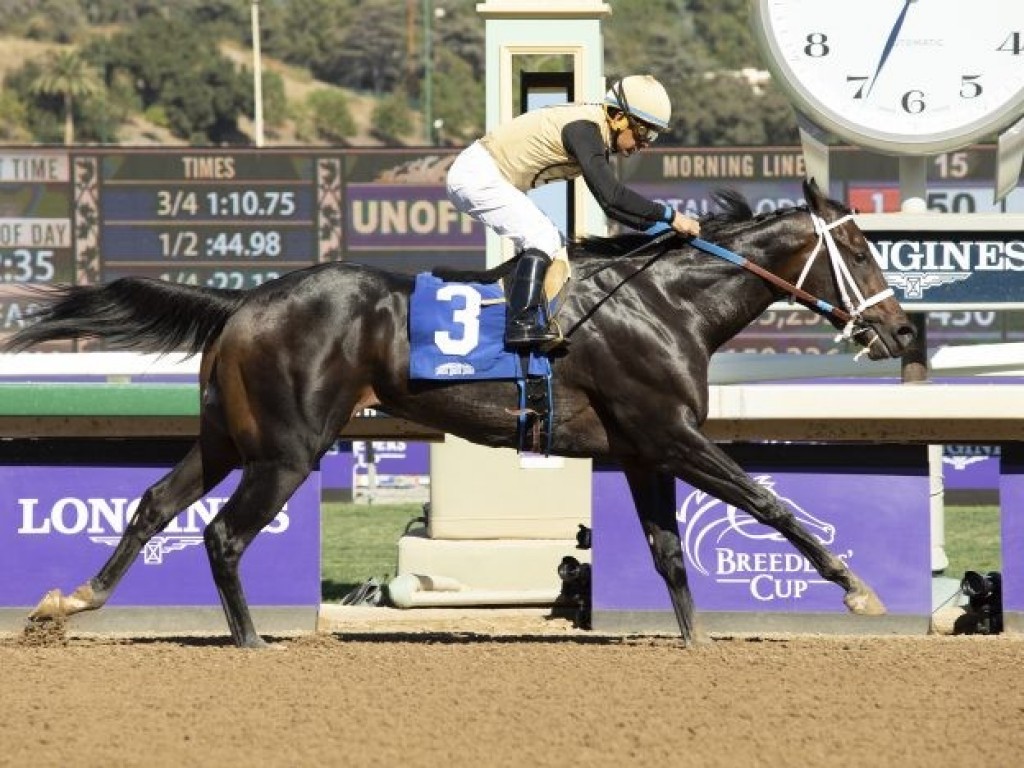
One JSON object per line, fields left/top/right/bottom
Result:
{"left": 398, "top": 530, "right": 590, "bottom": 604}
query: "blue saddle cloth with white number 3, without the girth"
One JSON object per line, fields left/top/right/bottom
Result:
{"left": 409, "top": 272, "right": 551, "bottom": 381}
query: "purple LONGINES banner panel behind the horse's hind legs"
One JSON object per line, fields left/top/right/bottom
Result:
{"left": 0, "top": 465, "right": 321, "bottom": 608}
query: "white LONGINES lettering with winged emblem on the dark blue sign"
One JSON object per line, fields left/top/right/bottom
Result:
{"left": 869, "top": 238, "right": 1024, "bottom": 299}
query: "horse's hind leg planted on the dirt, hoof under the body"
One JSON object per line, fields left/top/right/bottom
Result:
{"left": 203, "top": 461, "right": 309, "bottom": 648}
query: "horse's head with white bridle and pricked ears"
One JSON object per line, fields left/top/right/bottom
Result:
{"left": 797, "top": 179, "right": 914, "bottom": 359}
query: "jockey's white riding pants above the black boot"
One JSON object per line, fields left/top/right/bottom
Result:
{"left": 447, "top": 141, "right": 562, "bottom": 257}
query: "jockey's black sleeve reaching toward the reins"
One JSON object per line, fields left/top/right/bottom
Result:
{"left": 562, "top": 120, "right": 674, "bottom": 229}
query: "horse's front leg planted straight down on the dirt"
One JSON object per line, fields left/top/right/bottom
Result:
{"left": 625, "top": 466, "right": 709, "bottom": 646}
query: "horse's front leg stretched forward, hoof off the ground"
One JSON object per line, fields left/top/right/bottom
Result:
{"left": 671, "top": 426, "right": 886, "bottom": 615}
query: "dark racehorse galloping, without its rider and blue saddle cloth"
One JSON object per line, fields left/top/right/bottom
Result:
{"left": 7, "top": 181, "right": 913, "bottom": 647}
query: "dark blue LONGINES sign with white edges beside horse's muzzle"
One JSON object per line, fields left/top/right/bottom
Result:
{"left": 857, "top": 214, "right": 1024, "bottom": 310}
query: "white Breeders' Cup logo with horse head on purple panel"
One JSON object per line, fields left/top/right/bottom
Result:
{"left": 677, "top": 475, "right": 839, "bottom": 601}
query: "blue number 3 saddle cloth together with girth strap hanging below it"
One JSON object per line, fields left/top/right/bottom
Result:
{"left": 409, "top": 272, "right": 552, "bottom": 455}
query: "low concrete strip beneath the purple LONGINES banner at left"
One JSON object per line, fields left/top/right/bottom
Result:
{"left": 0, "top": 605, "right": 319, "bottom": 636}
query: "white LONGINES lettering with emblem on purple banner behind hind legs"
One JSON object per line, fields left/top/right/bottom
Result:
{"left": 17, "top": 497, "right": 291, "bottom": 565}
